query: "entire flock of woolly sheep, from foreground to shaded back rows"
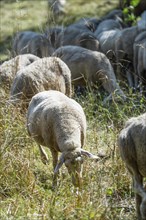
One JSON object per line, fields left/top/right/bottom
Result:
{"left": 0, "top": 2, "right": 146, "bottom": 220}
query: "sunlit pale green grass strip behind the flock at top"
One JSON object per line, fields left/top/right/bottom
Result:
{"left": 0, "top": 0, "right": 117, "bottom": 60}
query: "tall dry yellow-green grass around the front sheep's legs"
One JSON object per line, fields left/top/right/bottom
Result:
{"left": 0, "top": 88, "right": 146, "bottom": 220}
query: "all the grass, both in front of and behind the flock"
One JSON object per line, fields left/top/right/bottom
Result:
{"left": 0, "top": 0, "right": 146, "bottom": 220}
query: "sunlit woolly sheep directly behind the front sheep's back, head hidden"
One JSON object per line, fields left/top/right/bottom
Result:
{"left": 10, "top": 57, "right": 71, "bottom": 109}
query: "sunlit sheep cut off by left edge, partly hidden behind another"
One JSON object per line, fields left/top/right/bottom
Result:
{"left": 0, "top": 54, "right": 40, "bottom": 89}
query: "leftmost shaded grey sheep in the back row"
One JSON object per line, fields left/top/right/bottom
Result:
{"left": 12, "top": 31, "right": 54, "bottom": 58}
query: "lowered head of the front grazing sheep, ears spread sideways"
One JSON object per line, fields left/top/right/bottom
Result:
{"left": 54, "top": 142, "right": 99, "bottom": 187}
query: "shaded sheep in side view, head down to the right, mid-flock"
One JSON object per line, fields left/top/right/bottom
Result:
{"left": 52, "top": 46, "right": 126, "bottom": 103}
